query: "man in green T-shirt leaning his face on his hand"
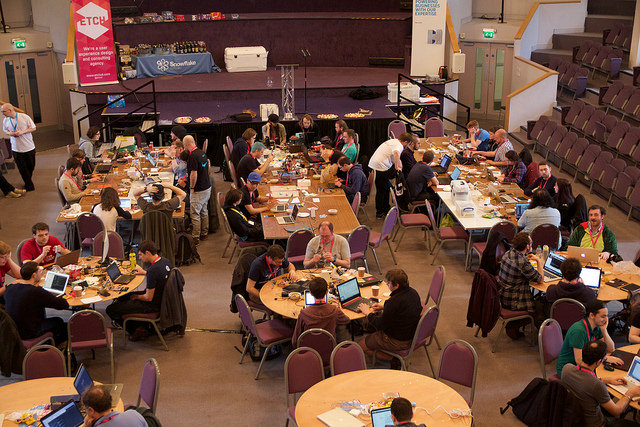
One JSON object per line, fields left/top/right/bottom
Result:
{"left": 556, "top": 299, "right": 622, "bottom": 378}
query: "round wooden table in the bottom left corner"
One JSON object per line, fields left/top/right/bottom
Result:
{"left": 0, "top": 377, "right": 124, "bottom": 415}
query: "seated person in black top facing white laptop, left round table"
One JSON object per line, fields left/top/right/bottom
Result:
{"left": 4, "top": 261, "right": 69, "bottom": 345}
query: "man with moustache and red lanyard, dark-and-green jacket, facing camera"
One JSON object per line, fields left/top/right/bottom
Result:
{"left": 563, "top": 205, "right": 618, "bottom": 260}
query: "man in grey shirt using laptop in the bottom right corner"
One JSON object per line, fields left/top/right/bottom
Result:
{"left": 562, "top": 341, "right": 640, "bottom": 427}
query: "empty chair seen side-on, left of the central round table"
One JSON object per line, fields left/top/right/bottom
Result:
{"left": 236, "top": 294, "right": 294, "bottom": 380}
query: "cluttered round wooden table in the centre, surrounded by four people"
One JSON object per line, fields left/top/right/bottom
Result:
{"left": 260, "top": 269, "right": 391, "bottom": 320}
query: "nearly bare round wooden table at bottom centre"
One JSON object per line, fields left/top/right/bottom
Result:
{"left": 296, "top": 369, "right": 471, "bottom": 427}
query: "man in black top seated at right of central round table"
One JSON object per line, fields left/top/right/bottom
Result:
{"left": 358, "top": 268, "right": 422, "bottom": 369}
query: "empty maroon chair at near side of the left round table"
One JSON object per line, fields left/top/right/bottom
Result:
{"left": 67, "top": 310, "right": 115, "bottom": 383}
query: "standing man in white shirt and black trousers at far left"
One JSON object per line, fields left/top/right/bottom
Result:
{"left": 1, "top": 103, "right": 36, "bottom": 191}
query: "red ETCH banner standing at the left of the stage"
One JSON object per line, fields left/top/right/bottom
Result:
{"left": 72, "top": 0, "right": 118, "bottom": 85}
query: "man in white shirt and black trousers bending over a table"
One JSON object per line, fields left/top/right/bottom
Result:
{"left": 369, "top": 132, "right": 418, "bottom": 218}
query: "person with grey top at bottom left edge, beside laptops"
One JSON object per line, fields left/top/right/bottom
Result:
{"left": 81, "top": 385, "right": 148, "bottom": 427}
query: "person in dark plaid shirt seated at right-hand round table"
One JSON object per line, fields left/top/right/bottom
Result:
{"left": 498, "top": 232, "right": 544, "bottom": 339}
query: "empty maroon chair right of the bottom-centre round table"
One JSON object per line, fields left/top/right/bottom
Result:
{"left": 436, "top": 340, "right": 478, "bottom": 407}
